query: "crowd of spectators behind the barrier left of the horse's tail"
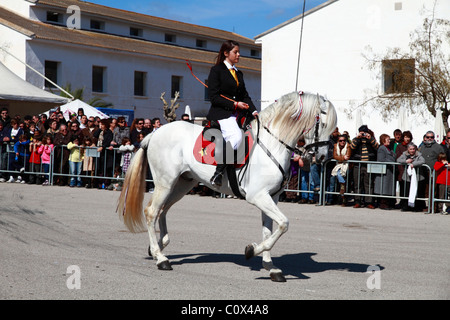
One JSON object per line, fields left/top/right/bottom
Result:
{"left": 0, "top": 108, "right": 167, "bottom": 190}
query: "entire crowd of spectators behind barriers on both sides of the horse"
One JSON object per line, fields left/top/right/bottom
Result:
{"left": 0, "top": 108, "right": 450, "bottom": 213}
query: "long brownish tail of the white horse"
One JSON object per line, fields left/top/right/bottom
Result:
{"left": 117, "top": 135, "right": 151, "bottom": 233}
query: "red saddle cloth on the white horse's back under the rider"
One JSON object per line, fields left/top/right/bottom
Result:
{"left": 193, "top": 131, "right": 254, "bottom": 168}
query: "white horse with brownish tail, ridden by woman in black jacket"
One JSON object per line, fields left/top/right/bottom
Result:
{"left": 117, "top": 92, "right": 337, "bottom": 282}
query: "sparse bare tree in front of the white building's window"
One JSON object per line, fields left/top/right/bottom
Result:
{"left": 346, "top": 1, "right": 450, "bottom": 130}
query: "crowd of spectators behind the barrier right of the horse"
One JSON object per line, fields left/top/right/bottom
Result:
{"left": 280, "top": 125, "right": 450, "bottom": 214}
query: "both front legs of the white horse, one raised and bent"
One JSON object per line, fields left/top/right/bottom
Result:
{"left": 245, "top": 195, "right": 289, "bottom": 282}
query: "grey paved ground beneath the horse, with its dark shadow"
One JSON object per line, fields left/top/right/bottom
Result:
{"left": 0, "top": 183, "right": 450, "bottom": 300}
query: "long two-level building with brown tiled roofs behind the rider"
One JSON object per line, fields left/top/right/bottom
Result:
{"left": 0, "top": 0, "right": 261, "bottom": 119}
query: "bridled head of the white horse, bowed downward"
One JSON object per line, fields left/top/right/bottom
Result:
{"left": 305, "top": 95, "right": 337, "bottom": 163}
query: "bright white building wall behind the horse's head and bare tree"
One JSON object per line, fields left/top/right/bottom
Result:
{"left": 256, "top": 0, "right": 450, "bottom": 143}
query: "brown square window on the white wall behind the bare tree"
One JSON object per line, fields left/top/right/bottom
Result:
{"left": 383, "top": 59, "right": 415, "bottom": 94}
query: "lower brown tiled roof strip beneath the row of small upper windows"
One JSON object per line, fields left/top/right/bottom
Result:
{"left": 0, "top": 5, "right": 261, "bottom": 71}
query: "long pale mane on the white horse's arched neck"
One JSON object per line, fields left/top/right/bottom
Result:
{"left": 255, "top": 92, "right": 336, "bottom": 145}
